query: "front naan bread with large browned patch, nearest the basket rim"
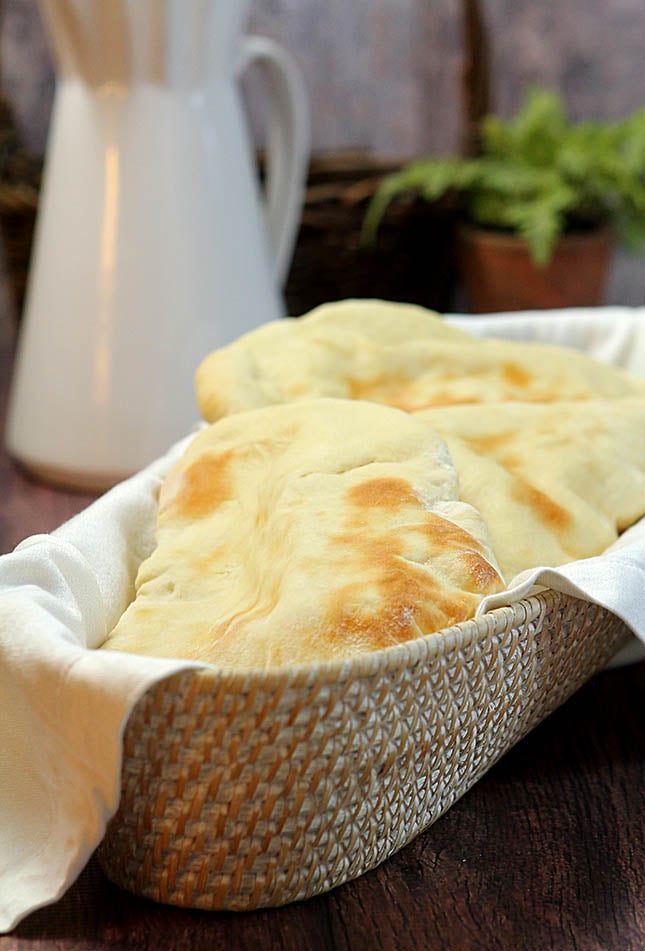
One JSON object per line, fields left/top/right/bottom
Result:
{"left": 104, "top": 399, "right": 504, "bottom": 668}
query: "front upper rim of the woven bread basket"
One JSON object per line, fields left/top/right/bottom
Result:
{"left": 143, "top": 588, "right": 580, "bottom": 693}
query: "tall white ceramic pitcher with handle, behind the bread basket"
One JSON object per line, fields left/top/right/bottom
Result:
{"left": 7, "top": 0, "right": 308, "bottom": 489}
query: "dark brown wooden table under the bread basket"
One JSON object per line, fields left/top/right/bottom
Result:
{"left": 0, "top": 338, "right": 645, "bottom": 951}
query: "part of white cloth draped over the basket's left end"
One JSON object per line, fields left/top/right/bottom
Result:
{"left": 0, "top": 440, "right": 203, "bottom": 933}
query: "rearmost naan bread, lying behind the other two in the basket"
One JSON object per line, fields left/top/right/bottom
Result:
{"left": 195, "top": 300, "right": 645, "bottom": 422}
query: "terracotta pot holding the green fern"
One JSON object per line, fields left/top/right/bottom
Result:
{"left": 457, "top": 225, "right": 613, "bottom": 314}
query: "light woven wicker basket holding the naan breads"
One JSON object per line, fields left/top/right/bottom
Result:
{"left": 99, "top": 591, "right": 628, "bottom": 910}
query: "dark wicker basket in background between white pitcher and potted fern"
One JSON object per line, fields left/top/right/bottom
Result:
{"left": 285, "top": 152, "right": 456, "bottom": 316}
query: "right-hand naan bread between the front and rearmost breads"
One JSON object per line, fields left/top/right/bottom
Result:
{"left": 417, "top": 399, "right": 645, "bottom": 583}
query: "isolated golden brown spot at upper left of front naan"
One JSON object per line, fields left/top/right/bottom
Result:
{"left": 161, "top": 450, "right": 233, "bottom": 518}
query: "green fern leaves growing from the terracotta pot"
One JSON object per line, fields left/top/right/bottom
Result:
{"left": 362, "top": 86, "right": 645, "bottom": 266}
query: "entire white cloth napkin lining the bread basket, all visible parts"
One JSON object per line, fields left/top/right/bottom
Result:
{"left": 0, "top": 308, "right": 645, "bottom": 933}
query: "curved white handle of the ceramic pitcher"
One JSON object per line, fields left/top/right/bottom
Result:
{"left": 239, "top": 36, "right": 309, "bottom": 286}
